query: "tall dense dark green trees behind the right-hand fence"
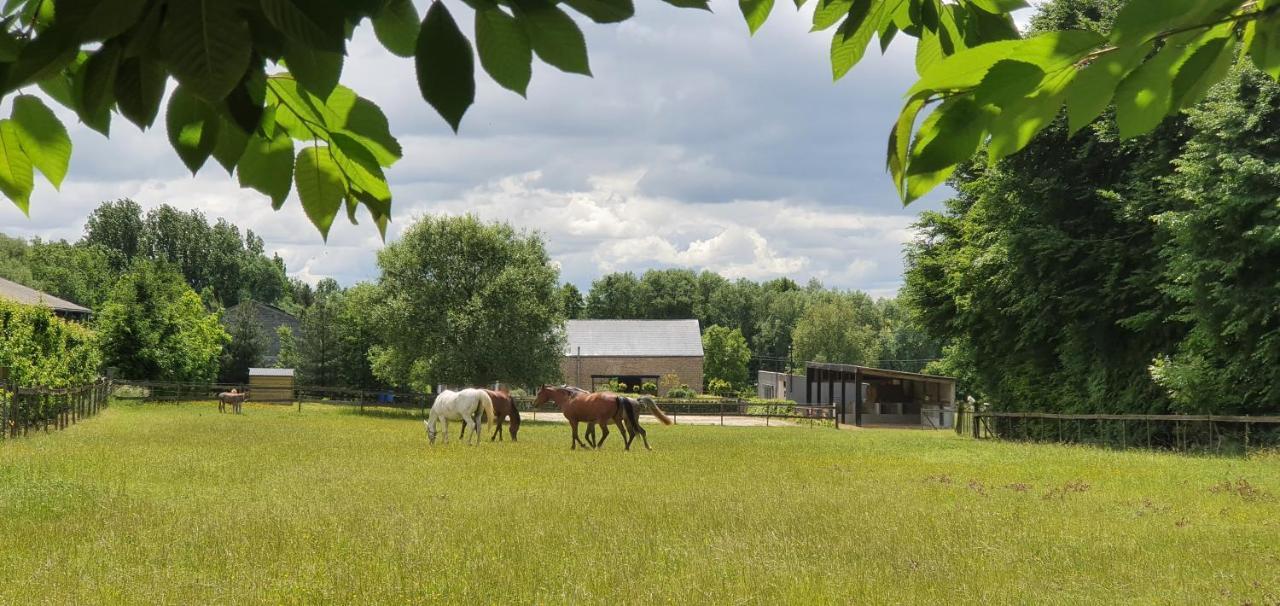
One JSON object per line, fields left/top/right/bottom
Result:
{"left": 904, "top": 0, "right": 1280, "bottom": 413}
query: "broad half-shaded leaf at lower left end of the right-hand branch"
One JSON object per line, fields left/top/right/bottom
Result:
{"left": 906, "top": 96, "right": 992, "bottom": 177}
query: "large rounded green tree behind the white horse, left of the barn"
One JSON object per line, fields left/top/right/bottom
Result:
{"left": 374, "top": 215, "right": 563, "bottom": 387}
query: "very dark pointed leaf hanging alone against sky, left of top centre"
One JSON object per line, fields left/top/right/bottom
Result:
{"left": 413, "top": 0, "right": 476, "bottom": 132}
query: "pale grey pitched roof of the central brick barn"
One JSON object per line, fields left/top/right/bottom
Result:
{"left": 564, "top": 320, "right": 703, "bottom": 357}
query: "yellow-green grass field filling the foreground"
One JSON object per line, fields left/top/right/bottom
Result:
{"left": 0, "top": 404, "right": 1280, "bottom": 605}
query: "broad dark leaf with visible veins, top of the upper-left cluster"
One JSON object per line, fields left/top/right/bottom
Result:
{"left": 160, "top": 0, "right": 251, "bottom": 102}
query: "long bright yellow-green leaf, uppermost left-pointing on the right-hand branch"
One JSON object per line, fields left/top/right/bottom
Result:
{"left": 908, "top": 29, "right": 1103, "bottom": 96}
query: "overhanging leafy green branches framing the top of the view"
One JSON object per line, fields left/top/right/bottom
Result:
{"left": 0, "top": 0, "right": 1280, "bottom": 229}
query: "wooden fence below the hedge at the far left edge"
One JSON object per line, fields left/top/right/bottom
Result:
{"left": 0, "top": 379, "right": 111, "bottom": 439}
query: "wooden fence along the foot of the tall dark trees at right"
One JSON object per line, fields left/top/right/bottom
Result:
{"left": 955, "top": 407, "right": 1280, "bottom": 454}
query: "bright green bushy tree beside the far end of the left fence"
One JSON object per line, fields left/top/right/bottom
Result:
{"left": 97, "top": 261, "right": 228, "bottom": 383}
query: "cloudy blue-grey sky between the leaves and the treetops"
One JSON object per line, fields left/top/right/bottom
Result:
{"left": 0, "top": 0, "right": 967, "bottom": 296}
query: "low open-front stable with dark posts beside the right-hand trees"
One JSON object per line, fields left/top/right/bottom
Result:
{"left": 805, "top": 363, "right": 956, "bottom": 429}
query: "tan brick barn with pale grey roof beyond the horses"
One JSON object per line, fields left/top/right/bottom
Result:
{"left": 561, "top": 320, "right": 703, "bottom": 395}
